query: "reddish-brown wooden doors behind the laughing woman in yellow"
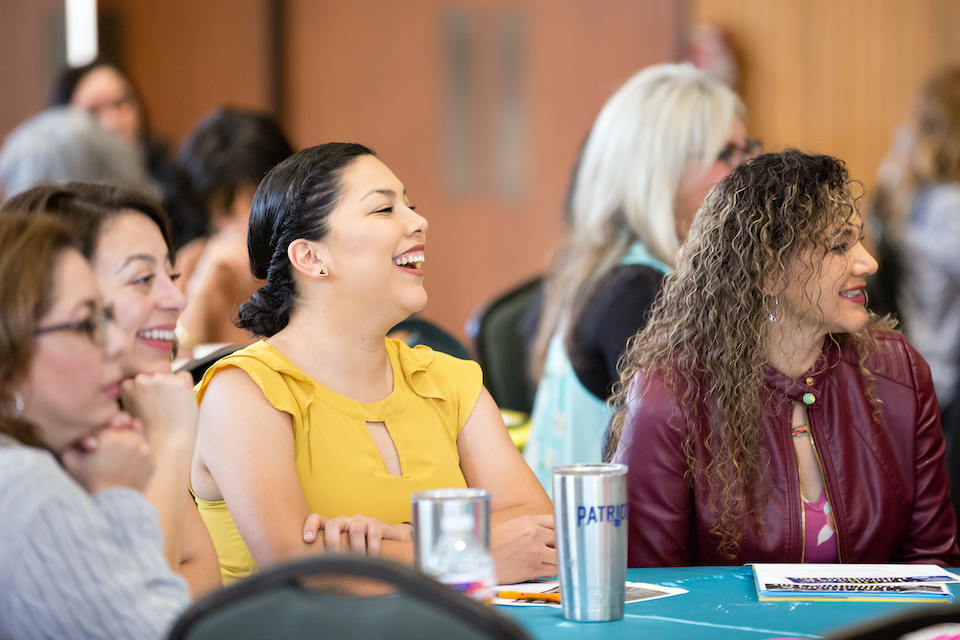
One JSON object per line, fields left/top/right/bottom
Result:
{"left": 284, "top": 0, "right": 682, "bottom": 335}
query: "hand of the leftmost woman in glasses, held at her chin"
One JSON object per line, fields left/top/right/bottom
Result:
{"left": 60, "top": 413, "right": 154, "bottom": 495}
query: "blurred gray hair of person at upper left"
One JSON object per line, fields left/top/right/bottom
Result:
{"left": 0, "top": 107, "right": 161, "bottom": 197}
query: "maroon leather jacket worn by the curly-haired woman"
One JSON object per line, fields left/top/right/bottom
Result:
{"left": 614, "top": 332, "right": 960, "bottom": 567}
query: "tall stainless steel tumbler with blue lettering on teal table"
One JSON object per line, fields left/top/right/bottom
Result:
{"left": 553, "top": 464, "right": 627, "bottom": 622}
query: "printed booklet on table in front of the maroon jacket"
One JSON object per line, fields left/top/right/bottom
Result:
{"left": 749, "top": 563, "right": 960, "bottom": 602}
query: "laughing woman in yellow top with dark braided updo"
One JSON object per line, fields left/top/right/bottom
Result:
{"left": 192, "top": 143, "right": 556, "bottom": 582}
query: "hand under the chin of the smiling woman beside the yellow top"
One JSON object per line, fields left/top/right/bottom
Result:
{"left": 120, "top": 372, "right": 197, "bottom": 450}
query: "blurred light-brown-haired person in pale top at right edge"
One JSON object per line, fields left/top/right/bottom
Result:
{"left": 876, "top": 68, "right": 960, "bottom": 414}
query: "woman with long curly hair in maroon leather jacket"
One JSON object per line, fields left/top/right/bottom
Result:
{"left": 608, "top": 150, "right": 960, "bottom": 567}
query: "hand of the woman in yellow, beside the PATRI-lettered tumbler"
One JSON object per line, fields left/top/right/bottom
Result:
{"left": 490, "top": 515, "right": 557, "bottom": 584}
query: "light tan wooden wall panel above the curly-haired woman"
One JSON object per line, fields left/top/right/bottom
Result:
{"left": 688, "top": 0, "right": 960, "bottom": 194}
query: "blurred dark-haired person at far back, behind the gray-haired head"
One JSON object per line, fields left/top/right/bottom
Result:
{"left": 52, "top": 60, "right": 206, "bottom": 247}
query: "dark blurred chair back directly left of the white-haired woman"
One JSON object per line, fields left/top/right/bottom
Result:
{"left": 470, "top": 278, "right": 542, "bottom": 413}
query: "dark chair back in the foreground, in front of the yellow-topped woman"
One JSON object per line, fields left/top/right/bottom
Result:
{"left": 169, "top": 555, "right": 528, "bottom": 640}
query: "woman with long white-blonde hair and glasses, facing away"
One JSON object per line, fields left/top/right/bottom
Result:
{"left": 524, "top": 65, "right": 758, "bottom": 491}
